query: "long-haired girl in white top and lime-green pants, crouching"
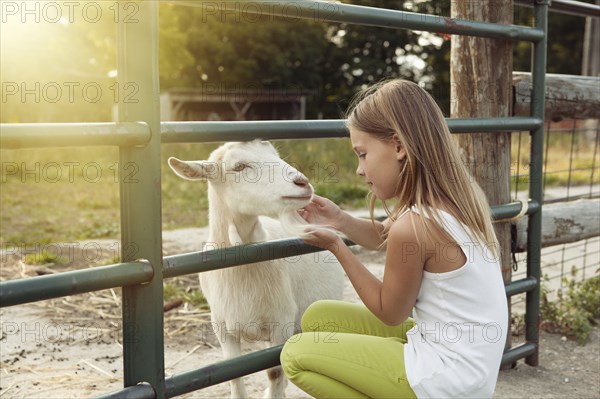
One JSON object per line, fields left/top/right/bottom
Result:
{"left": 281, "top": 80, "right": 508, "bottom": 398}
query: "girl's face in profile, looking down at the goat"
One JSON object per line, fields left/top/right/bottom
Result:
{"left": 350, "top": 129, "right": 406, "bottom": 200}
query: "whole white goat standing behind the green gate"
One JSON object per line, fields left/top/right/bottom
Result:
{"left": 169, "top": 140, "right": 344, "bottom": 398}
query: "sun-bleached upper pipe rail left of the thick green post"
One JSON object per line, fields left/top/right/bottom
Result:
{"left": 0, "top": 122, "right": 151, "bottom": 149}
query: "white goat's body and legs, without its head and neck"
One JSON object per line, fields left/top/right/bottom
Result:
{"left": 200, "top": 214, "right": 343, "bottom": 398}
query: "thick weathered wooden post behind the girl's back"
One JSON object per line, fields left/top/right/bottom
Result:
{"left": 450, "top": 0, "right": 513, "bottom": 367}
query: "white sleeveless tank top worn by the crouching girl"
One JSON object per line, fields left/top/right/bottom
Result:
{"left": 404, "top": 209, "right": 508, "bottom": 398}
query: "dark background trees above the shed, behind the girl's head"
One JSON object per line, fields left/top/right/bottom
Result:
{"left": 161, "top": 0, "right": 449, "bottom": 118}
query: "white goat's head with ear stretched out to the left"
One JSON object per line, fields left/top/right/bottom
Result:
{"left": 169, "top": 140, "right": 313, "bottom": 215}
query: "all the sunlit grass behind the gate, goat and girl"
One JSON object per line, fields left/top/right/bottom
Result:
{"left": 0, "top": 134, "right": 599, "bottom": 246}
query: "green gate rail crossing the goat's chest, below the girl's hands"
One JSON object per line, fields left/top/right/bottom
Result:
{"left": 0, "top": 200, "right": 539, "bottom": 307}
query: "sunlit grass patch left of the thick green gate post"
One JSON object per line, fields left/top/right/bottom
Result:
{"left": 0, "top": 148, "right": 120, "bottom": 245}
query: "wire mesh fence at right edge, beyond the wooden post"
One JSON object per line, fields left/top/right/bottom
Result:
{"left": 511, "top": 120, "right": 600, "bottom": 312}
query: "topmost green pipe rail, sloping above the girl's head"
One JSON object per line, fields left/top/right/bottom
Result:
{"left": 175, "top": 0, "right": 544, "bottom": 42}
